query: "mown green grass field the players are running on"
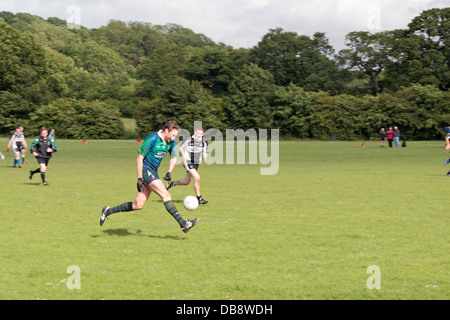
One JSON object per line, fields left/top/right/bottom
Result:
{"left": 0, "top": 139, "right": 450, "bottom": 300}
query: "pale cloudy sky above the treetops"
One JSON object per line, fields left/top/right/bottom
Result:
{"left": 0, "top": 0, "right": 450, "bottom": 51}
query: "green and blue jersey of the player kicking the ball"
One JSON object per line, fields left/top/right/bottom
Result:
{"left": 138, "top": 131, "right": 178, "bottom": 176}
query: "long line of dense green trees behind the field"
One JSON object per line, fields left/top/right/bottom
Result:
{"left": 0, "top": 8, "right": 450, "bottom": 140}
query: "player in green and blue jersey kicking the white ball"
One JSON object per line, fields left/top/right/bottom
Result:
{"left": 99, "top": 121, "right": 198, "bottom": 233}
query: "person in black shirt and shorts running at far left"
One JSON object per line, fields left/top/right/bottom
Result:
{"left": 30, "top": 127, "right": 58, "bottom": 186}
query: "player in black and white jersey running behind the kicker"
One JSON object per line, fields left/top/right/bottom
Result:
{"left": 166, "top": 128, "right": 209, "bottom": 204}
